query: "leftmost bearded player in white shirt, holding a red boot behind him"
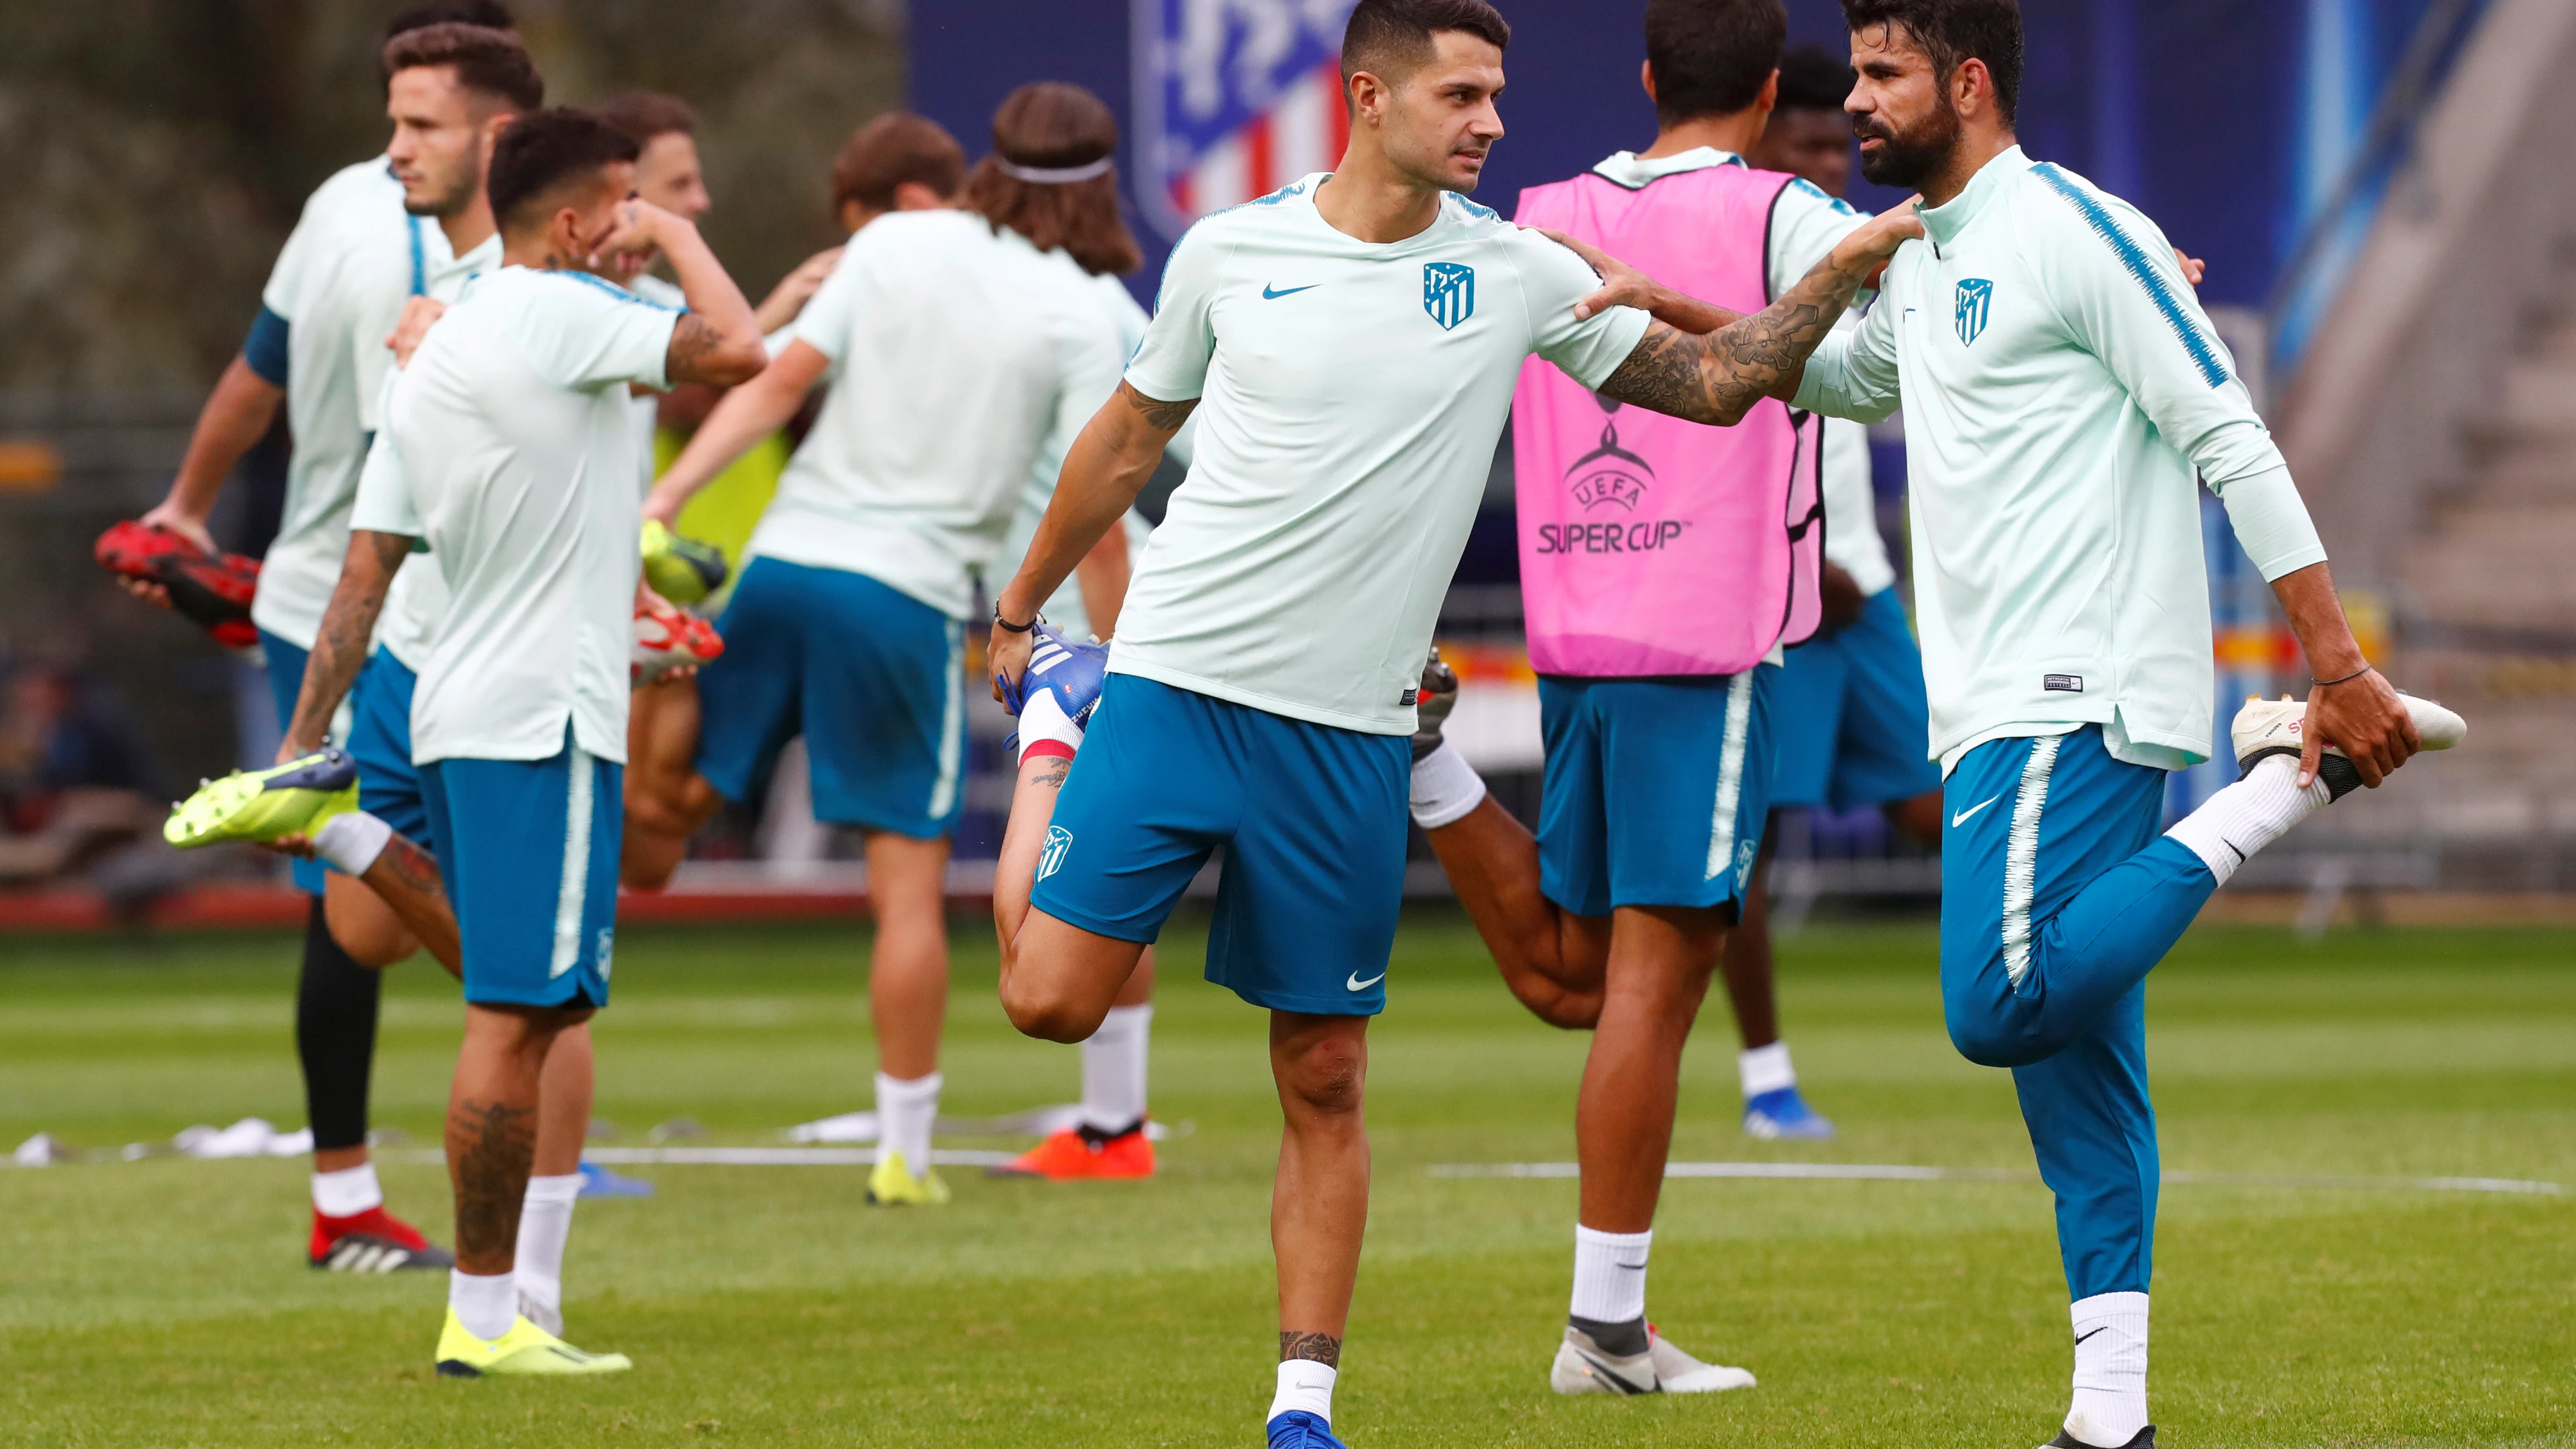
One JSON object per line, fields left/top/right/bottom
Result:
{"left": 125, "top": 0, "right": 528, "bottom": 1271}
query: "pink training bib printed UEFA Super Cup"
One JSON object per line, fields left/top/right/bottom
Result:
{"left": 1512, "top": 165, "right": 1824, "bottom": 677}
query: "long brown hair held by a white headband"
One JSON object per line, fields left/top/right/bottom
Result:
{"left": 966, "top": 80, "right": 1144, "bottom": 276}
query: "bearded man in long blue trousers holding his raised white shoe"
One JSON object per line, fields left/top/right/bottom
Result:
{"left": 1775, "top": 0, "right": 2465, "bottom": 1449}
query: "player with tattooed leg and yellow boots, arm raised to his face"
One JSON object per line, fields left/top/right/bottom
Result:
{"left": 296, "top": 111, "right": 765, "bottom": 1377}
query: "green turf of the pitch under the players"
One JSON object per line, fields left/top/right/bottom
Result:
{"left": 0, "top": 914, "right": 2576, "bottom": 1449}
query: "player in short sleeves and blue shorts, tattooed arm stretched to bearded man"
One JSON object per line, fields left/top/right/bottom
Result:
{"left": 992, "top": 0, "right": 1917, "bottom": 1446}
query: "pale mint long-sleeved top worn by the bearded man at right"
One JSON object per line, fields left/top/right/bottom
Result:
{"left": 1796, "top": 146, "right": 2326, "bottom": 770}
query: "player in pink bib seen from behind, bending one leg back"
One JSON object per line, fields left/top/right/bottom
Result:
{"left": 1414, "top": 0, "right": 1868, "bottom": 1392}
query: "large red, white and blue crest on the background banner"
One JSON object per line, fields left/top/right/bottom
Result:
{"left": 1128, "top": 0, "right": 1357, "bottom": 239}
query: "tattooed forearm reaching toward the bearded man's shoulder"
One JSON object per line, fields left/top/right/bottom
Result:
{"left": 1600, "top": 242, "right": 1878, "bottom": 427}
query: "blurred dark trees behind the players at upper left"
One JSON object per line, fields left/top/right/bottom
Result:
{"left": 0, "top": 0, "right": 902, "bottom": 391}
